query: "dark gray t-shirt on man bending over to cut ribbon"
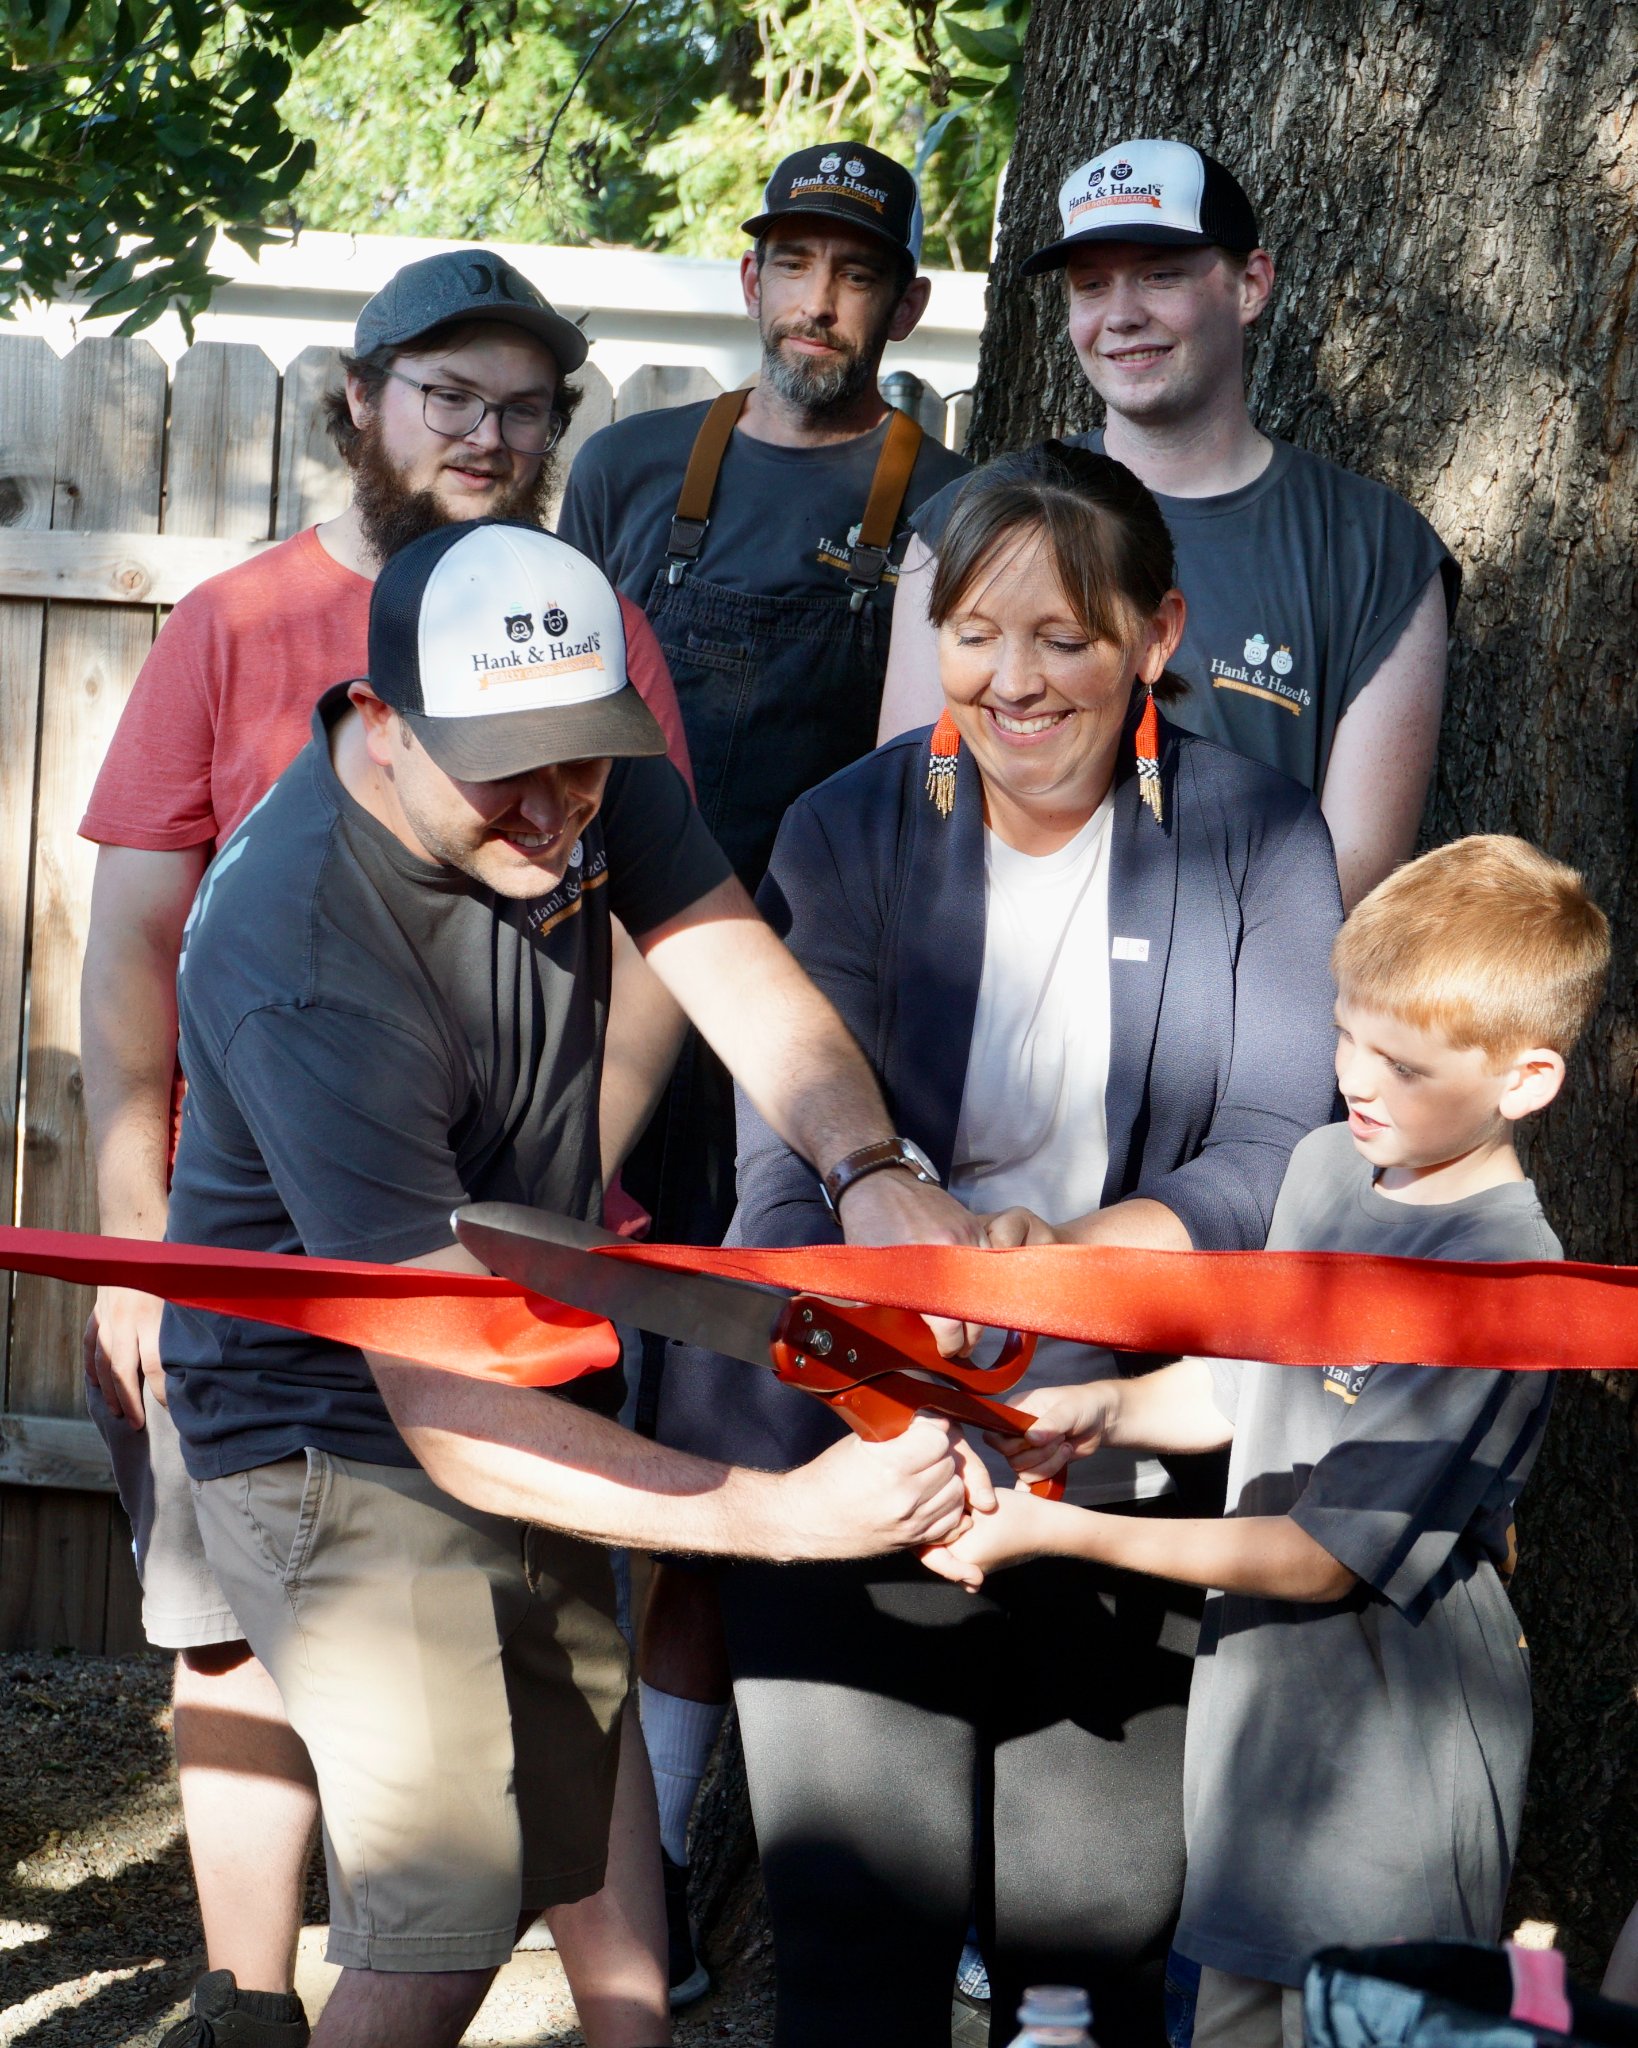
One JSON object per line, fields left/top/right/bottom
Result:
{"left": 160, "top": 686, "right": 729, "bottom": 1479}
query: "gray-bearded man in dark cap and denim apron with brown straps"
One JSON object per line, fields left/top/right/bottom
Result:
{"left": 559, "top": 143, "right": 968, "bottom": 2001}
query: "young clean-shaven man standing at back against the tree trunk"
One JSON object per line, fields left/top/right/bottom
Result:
{"left": 882, "top": 139, "right": 1460, "bottom": 903}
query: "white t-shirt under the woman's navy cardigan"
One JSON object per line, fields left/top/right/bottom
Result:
{"left": 950, "top": 797, "right": 1171, "bottom": 1507}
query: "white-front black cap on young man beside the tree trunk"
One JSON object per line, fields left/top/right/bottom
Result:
{"left": 1018, "top": 137, "right": 1257, "bottom": 276}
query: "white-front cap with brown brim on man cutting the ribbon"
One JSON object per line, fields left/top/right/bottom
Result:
{"left": 369, "top": 518, "right": 665, "bottom": 782}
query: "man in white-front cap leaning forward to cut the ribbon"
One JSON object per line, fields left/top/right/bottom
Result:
{"left": 162, "top": 520, "right": 985, "bottom": 2048}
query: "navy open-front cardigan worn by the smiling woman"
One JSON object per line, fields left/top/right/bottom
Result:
{"left": 659, "top": 719, "right": 1341, "bottom": 1468}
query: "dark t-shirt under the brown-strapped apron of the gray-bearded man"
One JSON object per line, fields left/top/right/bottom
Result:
{"left": 557, "top": 403, "right": 973, "bottom": 606}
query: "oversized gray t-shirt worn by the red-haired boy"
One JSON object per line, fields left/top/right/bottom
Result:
{"left": 1177, "top": 1124, "right": 1562, "bottom": 1985}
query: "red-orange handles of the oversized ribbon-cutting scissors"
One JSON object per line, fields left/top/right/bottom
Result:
{"left": 772, "top": 1294, "right": 1063, "bottom": 1501}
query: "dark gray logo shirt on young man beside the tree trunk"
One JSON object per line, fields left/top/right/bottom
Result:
{"left": 913, "top": 430, "right": 1462, "bottom": 797}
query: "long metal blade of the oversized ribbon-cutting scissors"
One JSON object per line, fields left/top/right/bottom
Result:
{"left": 452, "top": 1202, "right": 792, "bottom": 1366}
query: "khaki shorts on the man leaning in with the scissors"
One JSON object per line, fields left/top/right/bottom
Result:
{"left": 195, "top": 1450, "right": 629, "bottom": 1970}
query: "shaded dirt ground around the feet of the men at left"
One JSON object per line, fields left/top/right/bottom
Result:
{"left": 0, "top": 1651, "right": 772, "bottom": 2048}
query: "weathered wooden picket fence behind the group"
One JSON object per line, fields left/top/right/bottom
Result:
{"left": 0, "top": 336, "right": 966, "bottom": 1651}
